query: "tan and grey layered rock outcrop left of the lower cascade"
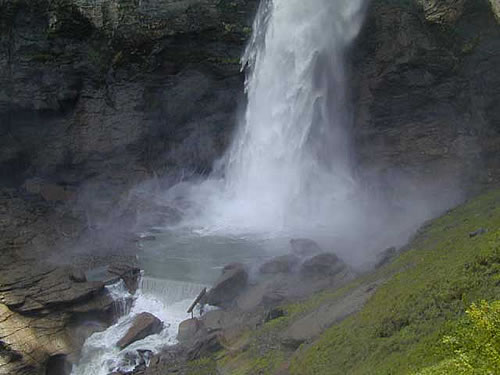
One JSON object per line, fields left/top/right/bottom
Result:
{"left": 0, "top": 261, "right": 139, "bottom": 374}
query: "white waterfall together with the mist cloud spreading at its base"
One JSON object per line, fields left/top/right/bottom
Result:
{"left": 142, "top": 0, "right": 462, "bottom": 267}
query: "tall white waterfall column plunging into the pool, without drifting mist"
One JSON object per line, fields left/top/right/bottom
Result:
{"left": 175, "top": 0, "right": 365, "bottom": 238}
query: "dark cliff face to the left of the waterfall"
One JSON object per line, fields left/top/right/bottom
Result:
{"left": 0, "top": 0, "right": 256, "bottom": 192}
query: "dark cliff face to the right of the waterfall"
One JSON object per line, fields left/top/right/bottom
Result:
{"left": 353, "top": 0, "right": 500, "bottom": 200}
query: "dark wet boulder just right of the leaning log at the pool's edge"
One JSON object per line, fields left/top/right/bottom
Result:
{"left": 205, "top": 263, "right": 248, "bottom": 307}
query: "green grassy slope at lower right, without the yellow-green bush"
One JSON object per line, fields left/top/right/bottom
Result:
{"left": 191, "top": 190, "right": 500, "bottom": 375}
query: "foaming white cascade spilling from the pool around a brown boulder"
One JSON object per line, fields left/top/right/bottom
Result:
{"left": 71, "top": 277, "right": 204, "bottom": 375}
